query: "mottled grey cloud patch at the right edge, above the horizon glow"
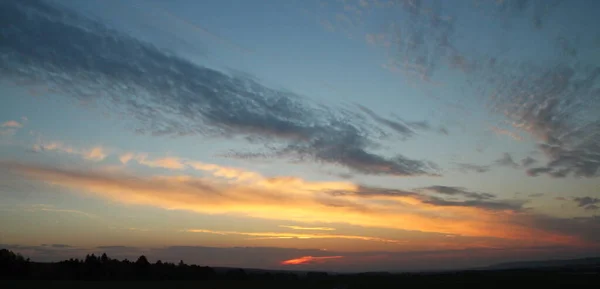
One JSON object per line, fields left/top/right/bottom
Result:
{"left": 501, "top": 64, "right": 600, "bottom": 178}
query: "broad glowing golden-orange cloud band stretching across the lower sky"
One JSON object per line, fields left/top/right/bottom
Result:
{"left": 0, "top": 162, "right": 573, "bottom": 242}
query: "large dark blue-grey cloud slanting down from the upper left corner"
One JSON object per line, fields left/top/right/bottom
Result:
{"left": 0, "top": 1, "right": 436, "bottom": 176}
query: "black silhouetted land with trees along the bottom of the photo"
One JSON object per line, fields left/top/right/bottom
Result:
{"left": 0, "top": 250, "right": 600, "bottom": 289}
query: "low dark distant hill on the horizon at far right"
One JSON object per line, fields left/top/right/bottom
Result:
{"left": 480, "top": 257, "right": 600, "bottom": 270}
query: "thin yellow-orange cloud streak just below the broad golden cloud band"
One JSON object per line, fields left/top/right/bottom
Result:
{"left": 184, "top": 229, "right": 402, "bottom": 243}
